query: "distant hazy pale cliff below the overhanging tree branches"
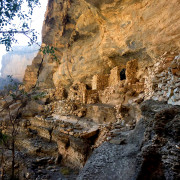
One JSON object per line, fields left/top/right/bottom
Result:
{"left": 1, "top": 45, "right": 39, "bottom": 82}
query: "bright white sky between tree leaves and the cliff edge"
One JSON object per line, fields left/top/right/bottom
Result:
{"left": 0, "top": 0, "right": 48, "bottom": 69}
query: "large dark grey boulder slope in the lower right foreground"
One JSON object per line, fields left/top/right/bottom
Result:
{"left": 77, "top": 101, "right": 180, "bottom": 180}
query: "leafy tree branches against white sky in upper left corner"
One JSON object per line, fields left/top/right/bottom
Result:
{"left": 0, "top": 0, "right": 40, "bottom": 51}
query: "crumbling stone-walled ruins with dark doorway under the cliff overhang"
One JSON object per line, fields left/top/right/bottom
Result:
{"left": 54, "top": 53, "right": 180, "bottom": 129}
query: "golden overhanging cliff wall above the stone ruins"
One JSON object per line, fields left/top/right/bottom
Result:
{"left": 25, "top": 0, "right": 180, "bottom": 90}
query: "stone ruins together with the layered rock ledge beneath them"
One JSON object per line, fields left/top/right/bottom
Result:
{"left": 1, "top": 53, "right": 180, "bottom": 178}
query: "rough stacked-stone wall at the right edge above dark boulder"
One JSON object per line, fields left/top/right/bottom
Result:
{"left": 145, "top": 53, "right": 180, "bottom": 105}
